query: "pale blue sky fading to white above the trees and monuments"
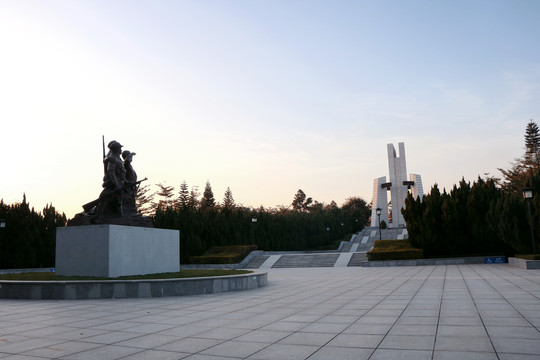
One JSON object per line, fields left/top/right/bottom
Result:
{"left": 0, "top": 0, "right": 540, "bottom": 217}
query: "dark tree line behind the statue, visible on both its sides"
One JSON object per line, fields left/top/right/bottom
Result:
{"left": 0, "top": 181, "right": 370, "bottom": 269}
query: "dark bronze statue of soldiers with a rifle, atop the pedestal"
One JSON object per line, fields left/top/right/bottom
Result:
{"left": 68, "top": 140, "right": 152, "bottom": 227}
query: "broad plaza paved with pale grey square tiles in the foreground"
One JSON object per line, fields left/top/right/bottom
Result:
{"left": 0, "top": 264, "right": 540, "bottom": 360}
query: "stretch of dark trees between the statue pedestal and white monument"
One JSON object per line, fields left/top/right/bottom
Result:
{"left": 154, "top": 181, "right": 370, "bottom": 263}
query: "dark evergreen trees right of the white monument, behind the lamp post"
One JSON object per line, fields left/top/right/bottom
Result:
{"left": 402, "top": 120, "right": 540, "bottom": 257}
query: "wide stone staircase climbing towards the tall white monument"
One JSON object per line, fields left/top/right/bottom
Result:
{"left": 244, "top": 227, "right": 407, "bottom": 269}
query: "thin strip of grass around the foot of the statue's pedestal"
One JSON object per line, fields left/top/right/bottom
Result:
{"left": 0, "top": 269, "right": 253, "bottom": 281}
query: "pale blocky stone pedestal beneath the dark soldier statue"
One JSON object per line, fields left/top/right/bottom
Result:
{"left": 56, "top": 224, "right": 180, "bottom": 277}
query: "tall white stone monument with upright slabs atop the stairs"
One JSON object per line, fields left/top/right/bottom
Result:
{"left": 371, "top": 142, "right": 424, "bottom": 227}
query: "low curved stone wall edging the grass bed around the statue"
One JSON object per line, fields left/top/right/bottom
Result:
{"left": 0, "top": 272, "right": 268, "bottom": 300}
